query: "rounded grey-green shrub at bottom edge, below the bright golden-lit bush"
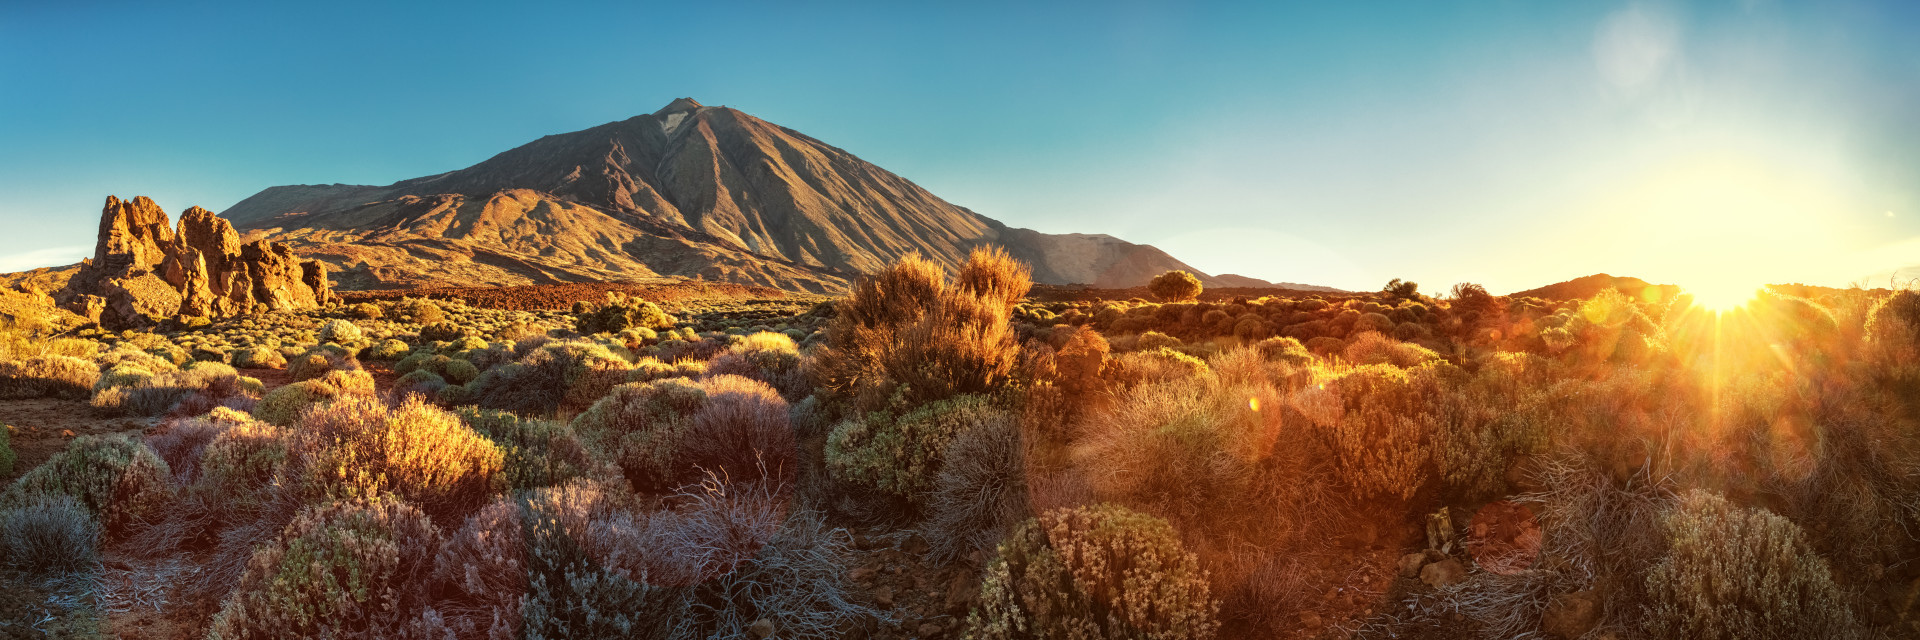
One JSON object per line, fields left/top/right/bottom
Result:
{"left": 207, "top": 498, "right": 440, "bottom": 640}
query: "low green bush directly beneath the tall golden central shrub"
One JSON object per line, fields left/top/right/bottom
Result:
{"left": 826, "top": 396, "right": 1006, "bottom": 505}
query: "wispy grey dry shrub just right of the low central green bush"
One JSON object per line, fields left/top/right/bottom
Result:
{"left": 925, "top": 401, "right": 1029, "bottom": 559}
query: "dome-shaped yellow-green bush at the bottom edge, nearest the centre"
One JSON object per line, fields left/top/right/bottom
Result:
{"left": 966, "top": 505, "right": 1219, "bottom": 640}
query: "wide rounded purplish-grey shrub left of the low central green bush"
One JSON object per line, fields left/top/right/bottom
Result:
{"left": 572, "top": 375, "right": 799, "bottom": 492}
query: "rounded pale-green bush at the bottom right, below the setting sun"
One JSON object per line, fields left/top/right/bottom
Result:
{"left": 1645, "top": 490, "right": 1860, "bottom": 640}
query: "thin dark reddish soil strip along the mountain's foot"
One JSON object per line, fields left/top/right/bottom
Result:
{"left": 340, "top": 281, "right": 789, "bottom": 311}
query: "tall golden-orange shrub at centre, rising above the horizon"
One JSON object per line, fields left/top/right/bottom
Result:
{"left": 816, "top": 248, "right": 1033, "bottom": 411}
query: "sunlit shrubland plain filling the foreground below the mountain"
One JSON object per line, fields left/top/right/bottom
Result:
{"left": 0, "top": 261, "right": 1920, "bottom": 638}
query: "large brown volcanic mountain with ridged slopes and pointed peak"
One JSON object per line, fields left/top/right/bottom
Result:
{"left": 221, "top": 98, "right": 1217, "bottom": 292}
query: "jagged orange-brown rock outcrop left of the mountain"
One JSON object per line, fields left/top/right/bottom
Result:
{"left": 54, "top": 196, "right": 338, "bottom": 329}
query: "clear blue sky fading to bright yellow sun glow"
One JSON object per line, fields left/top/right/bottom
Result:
{"left": 0, "top": 0, "right": 1920, "bottom": 292}
